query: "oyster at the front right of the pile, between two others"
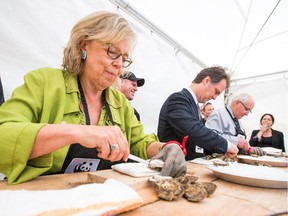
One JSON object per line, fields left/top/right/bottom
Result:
{"left": 184, "top": 182, "right": 208, "bottom": 202}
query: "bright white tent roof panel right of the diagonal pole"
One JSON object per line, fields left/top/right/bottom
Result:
{"left": 129, "top": 0, "right": 288, "bottom": 78}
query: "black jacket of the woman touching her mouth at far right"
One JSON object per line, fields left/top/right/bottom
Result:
{"left": 249, "top": 129, "right": 285, "bottom": 152}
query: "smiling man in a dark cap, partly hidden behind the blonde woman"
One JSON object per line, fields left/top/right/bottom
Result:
{"left": 117, "top": 71, "right": 145, "bottom": 121}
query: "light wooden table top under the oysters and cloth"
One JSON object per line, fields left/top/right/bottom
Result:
{"left": 0, "top": 162, "right": 288, "bottom": 216}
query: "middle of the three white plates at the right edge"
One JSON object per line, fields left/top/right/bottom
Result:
{"left": 237, "top": 155, "right": 288, "bottom": 167}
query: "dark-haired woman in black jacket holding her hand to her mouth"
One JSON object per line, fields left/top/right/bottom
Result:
{"left": 249, "top": 113, "right": 285, "bottom": 152}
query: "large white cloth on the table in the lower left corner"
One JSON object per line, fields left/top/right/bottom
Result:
{"left": 0, "top": 179, "right": 143, "bottom": 216}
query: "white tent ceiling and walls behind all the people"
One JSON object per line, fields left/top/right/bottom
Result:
{"left": 0, "top": 0, "right": 288, "bottom": 148}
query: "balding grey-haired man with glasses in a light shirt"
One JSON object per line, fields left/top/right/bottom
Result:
{"left": 205, "top": 93, "right": 264, "bottom": 155}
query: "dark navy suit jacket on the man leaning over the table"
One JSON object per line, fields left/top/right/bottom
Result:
{"left": 158, "top": 88, "right": 227, "bottom": 160}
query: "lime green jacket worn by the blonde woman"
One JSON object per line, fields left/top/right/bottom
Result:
{"left": 0, "top": 68, "right": 158, "bottom": 184}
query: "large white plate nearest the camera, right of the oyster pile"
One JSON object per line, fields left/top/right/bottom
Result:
{"left": 207, "top": 162, "right": 288, "bottom": 188}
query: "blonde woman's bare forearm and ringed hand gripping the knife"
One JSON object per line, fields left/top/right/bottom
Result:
{"left": 30, "top": 124, "right": 130, "bottom": 161}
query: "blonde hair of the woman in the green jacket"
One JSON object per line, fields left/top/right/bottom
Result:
{"left": 62, "top": 11, "right": 136, "bottom": 75}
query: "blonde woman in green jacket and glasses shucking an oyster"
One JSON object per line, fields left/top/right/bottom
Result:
{"left": 0, "top": 12, "right": 186, "bottom": 184}
